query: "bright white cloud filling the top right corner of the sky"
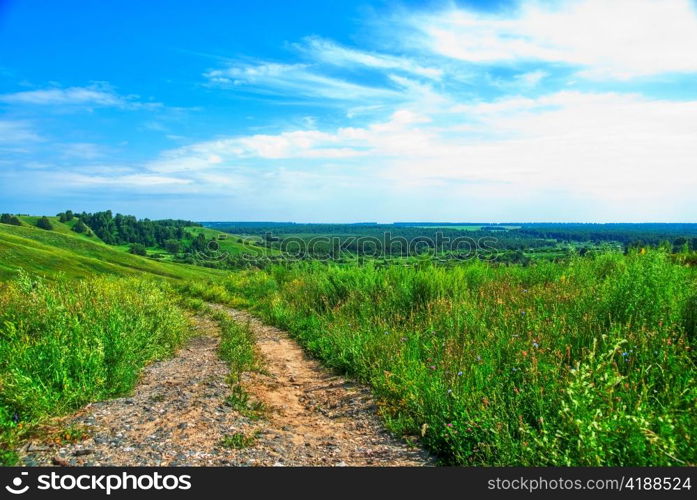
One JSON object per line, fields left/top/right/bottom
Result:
{"left": 411, "top": 0, "right": 697, "bottom": 79}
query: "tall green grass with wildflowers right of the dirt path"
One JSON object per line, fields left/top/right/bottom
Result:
{"left": 217, "top": 251, "right": 697, "bottom": 466}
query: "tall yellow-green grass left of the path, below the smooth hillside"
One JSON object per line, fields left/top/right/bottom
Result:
{"left": 0, "top": 274, "right": 187, "bottom": 462}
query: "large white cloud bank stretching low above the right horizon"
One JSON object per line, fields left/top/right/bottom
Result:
{"left": 139, "top": 92, "right": 697, "bottom": 218}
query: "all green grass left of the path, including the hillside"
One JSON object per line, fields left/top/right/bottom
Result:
{"left": 0, "top": 221, "right": 225, "bottom": 463}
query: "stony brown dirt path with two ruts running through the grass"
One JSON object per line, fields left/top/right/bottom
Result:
{"left": 23, "top": 309, "right": 432, "bottom": 466}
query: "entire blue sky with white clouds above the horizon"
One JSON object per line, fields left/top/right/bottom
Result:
{"left": 0, "top": 0, "right": 697, "bottom": 222}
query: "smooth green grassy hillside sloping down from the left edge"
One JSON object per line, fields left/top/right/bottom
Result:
{"left": 0, "top": 222, "right": 224, "bottom": 281}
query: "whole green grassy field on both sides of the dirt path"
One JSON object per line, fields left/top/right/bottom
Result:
{"left": 0, "top": 217, "right": 697, "bottom": 466}
